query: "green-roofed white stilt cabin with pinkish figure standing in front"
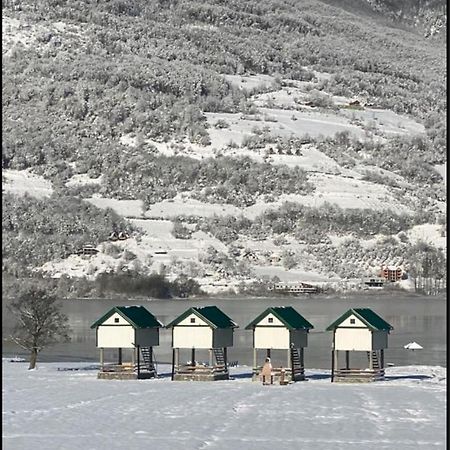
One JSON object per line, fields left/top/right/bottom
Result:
{"left": 245, "top": 306, "right": 314, "bottom": 383}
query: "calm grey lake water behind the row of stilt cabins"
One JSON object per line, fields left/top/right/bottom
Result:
{"left": 2, "top": 293, "right": 447, "bottom": 369}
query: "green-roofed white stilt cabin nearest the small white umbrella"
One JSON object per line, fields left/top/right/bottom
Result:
{"left": 326, "top": 308, "right": 394, "bottom": 382}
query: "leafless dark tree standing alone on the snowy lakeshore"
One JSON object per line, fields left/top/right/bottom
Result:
{"left": 8, "top": 285, "right": 70, "bottom": 370}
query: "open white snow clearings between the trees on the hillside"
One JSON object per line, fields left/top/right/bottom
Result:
{"left": 3, "top": 73, "right": 446, "bottom": 293}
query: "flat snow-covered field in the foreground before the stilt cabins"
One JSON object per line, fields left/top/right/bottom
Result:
{"left": 3, "top": 360, "right": 446, "bottom": 450}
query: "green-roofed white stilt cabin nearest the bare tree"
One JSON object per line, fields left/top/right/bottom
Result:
{"left": 91, "top": 306, "right": 164, "bottom": 380}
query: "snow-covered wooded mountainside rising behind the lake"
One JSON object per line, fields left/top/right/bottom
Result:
{"left": 2, "top": 0, "right": 446, "bottom": 292}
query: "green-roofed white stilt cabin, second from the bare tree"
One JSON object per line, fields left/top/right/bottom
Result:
{"left": 166, "top": 306, "right": 237, "bottom": 381}
